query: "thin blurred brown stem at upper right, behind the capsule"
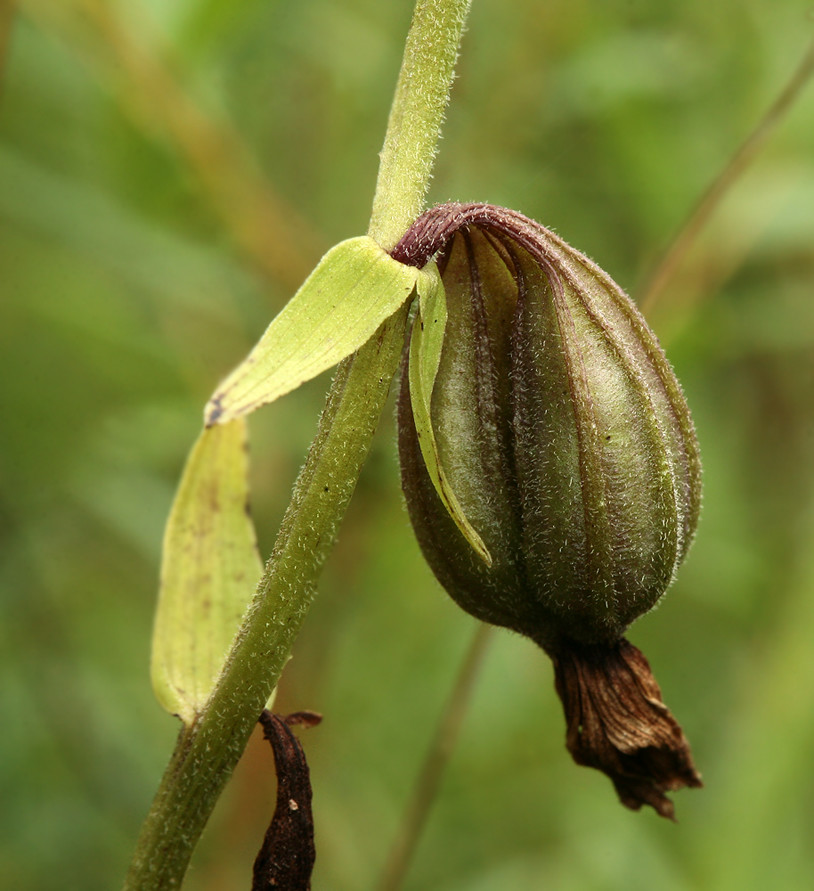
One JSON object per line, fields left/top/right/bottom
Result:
{"left": 639, "top": 41, "right": 814, "bottom": 315}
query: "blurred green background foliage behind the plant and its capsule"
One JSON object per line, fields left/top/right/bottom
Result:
{"left": 0, "top": 0, "right": 814, "bottom": 891}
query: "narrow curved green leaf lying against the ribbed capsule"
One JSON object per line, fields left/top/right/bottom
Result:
{"left": 409, "top": 266, "right": 492, "bottom": 566}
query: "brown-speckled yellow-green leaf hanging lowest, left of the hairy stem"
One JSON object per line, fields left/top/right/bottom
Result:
{"left": 151, "top": 420, "right": 263, "bottom": 724}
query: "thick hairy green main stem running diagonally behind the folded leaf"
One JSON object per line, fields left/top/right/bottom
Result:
{"left": 124, "top": 0, "right": 469, "bottom": 891}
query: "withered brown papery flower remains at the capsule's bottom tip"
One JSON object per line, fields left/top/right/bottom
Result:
{"left": 551, "top": 639, "right": 702, "bottom": 819}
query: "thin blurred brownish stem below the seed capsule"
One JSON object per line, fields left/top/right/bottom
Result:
{"left": 379, "top": 623, "right": 495, "bottom": 891}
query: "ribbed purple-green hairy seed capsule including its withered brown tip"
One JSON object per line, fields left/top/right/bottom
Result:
{"left": 393, "top": 204, "right": 701, "bottom": 817}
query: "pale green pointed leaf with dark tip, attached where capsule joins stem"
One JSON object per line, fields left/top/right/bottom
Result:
{"left": 205, "top": 236, "right": 419, "bottom": 426}
